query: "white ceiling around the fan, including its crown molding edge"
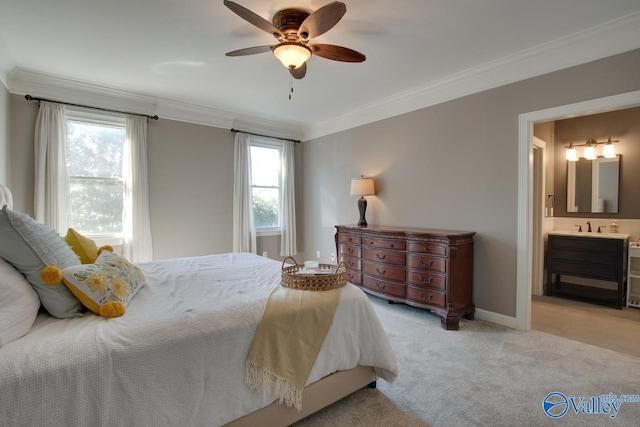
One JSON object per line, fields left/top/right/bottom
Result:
{"left": 0, "top": 0, "right": 640, "bottom": 139}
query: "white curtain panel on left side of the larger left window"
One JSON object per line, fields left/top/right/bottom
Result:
{"left": 34, "top": 101, "right": 71, "bottom": 234}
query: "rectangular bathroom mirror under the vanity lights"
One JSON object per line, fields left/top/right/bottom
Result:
{"left": 567, "top": 155, "right": 620, "bottom": 213}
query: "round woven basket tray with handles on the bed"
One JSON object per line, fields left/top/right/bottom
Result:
{"left": 281, "top": 257, "right": 347, "bottom": 291}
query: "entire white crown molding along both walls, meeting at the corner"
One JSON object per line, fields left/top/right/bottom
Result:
{"left": 5, "top": 12, "right": 640, "bottom": 140}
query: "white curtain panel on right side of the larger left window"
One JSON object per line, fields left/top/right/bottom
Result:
{"left": 122, "top": 116, "right": 153, "bottom": 262}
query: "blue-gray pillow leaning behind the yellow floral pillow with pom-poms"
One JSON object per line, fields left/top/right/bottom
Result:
{"left": 0, "top": 206, "right": 84, "bottom": 319}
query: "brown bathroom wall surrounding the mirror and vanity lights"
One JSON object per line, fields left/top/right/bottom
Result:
{"left": 554, "top": 107, "right": 640, "bottom": 219}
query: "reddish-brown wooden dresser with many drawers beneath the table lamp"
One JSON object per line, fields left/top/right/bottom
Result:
{"left": 335, "top": 225, "right": 475, "bottom": 329}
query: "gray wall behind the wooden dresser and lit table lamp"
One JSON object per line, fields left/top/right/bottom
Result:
{"left": 303, "top": 50, "right": 640, "bottom": 317}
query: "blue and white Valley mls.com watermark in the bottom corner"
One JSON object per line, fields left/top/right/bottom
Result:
{"left": 542, "top": 391, "right": 640, "bottom": 419}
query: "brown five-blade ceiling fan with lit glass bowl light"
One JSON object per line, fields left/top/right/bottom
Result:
{"left": 224, "top": 0, "right": 366, "bottom": 79}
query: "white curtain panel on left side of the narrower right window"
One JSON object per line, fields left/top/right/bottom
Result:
{"left": 233, "top": 132, "right": 257, "bottom": 254}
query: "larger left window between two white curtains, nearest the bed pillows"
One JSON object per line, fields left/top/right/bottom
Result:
{"left": 67, "top": 109, "right": 126, "bottom": 238}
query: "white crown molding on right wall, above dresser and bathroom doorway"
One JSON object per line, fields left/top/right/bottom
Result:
{"left": 304, "top": 12, "right": 640, "bottom": 140}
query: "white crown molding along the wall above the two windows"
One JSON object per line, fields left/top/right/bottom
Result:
{"left": 7, "top": 69, "right": 302, "bottom": 139}
